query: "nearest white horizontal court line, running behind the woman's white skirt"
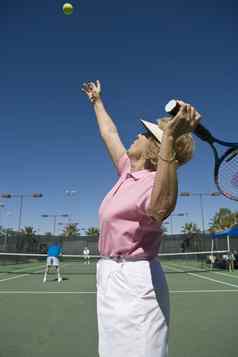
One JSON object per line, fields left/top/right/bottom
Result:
{"left": 0, "top": 289, "right": 238, "bottom": 295}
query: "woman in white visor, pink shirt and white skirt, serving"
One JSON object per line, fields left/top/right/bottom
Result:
{"left": 82, "top": 81, "right": 200, "bottom": 357}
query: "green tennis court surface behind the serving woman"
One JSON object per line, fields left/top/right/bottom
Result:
{"left": 0, "top": 252, "right": 238, "bottom": 357}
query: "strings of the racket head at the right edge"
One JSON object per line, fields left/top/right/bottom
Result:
{"left": 216, "top": 150, "right": 238, "bottom": 201}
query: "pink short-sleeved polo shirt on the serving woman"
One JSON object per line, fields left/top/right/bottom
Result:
{"left": 99, "top": 153, "right": 162, "bottom": 258}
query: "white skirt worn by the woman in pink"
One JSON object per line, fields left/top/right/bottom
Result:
{"left": 97, "top": 258, "right": 169, "bottom": 357}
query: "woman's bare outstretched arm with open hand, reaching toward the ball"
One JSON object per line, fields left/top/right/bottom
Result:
{"left": 82, "top": 81, "right": 126, "bottom": 167}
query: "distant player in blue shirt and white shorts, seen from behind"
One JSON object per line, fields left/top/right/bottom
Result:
{"left": 43, "top": 242, "right": 63, "bottom": 283}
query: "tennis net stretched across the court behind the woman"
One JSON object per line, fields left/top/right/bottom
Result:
{"left": 0, "top": 250, "right": 231, "bottom": 275}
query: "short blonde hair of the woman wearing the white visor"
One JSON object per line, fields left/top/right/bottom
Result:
{"left": 144, "top": 117, "right": 195, "bottom": 170}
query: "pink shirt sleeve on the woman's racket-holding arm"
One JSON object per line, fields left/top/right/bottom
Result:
{"left": 136, "top": 186, "right": 162, "bottom": 231}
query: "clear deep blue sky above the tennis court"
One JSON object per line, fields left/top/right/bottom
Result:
{"left": 0, "top": 0, "right": 238, "bottom": 232}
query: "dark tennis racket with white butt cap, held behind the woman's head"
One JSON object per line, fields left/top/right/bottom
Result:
{"left": 165, "top": 99, "right": 238, "bottom": 201}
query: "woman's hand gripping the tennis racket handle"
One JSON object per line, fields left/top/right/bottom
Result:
{"left": 164, "top": 100, "right": 201, "bottom": 140}
